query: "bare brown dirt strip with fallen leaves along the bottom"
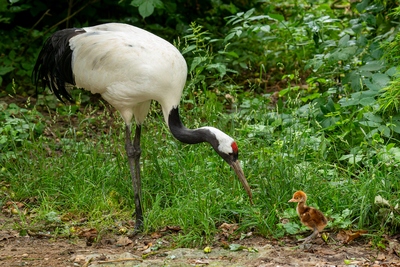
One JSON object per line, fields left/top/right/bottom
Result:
{"left": 0, "top": 215, "right": 400, "bottom": 267}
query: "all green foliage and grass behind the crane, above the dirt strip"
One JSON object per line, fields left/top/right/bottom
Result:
{"left": 0, "top": 0, "right": 400, "bottom": 245}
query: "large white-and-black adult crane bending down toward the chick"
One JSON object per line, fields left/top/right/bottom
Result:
{"left": 32, "top": 23, "right": 252, "bottom": 230}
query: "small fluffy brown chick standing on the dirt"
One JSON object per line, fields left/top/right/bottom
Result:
{"left": 289, "top": 191, "right": 328, "bottom": 244}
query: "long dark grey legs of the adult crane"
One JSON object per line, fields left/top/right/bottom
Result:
{"left": 125, "top": 124, "right": 143, "bottom": 230}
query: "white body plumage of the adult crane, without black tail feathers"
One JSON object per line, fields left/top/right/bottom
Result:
{"left": 70, "top": 23, "right": 187, "bottom": 124}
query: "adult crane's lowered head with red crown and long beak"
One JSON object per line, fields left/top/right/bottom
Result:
{"left": 200, "top": 127, "right": 254, "bottom": 205}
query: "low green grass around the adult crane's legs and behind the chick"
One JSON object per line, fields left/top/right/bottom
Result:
{"left": 0, "top": 96, "right": 400, "bottom": 246}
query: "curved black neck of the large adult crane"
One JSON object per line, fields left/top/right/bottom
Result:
{"left": 168, "top": 107, "right": 215, "bottom": 144}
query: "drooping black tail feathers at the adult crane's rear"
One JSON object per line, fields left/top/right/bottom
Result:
{"left": 32, "top": 28, "right": 85, "bottom": 102}
